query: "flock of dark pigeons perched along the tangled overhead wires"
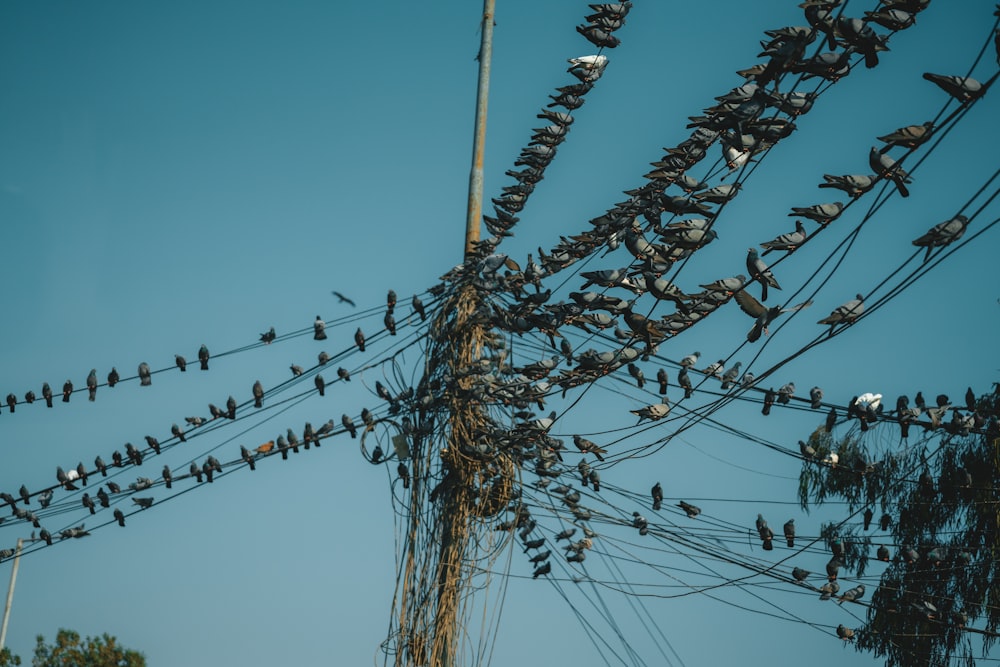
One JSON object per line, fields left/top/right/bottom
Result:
{"left": 0, "top": 0, "right": 1000, "bottom": 656}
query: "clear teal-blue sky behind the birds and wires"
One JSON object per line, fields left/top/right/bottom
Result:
{"left": 0, "top": 0, "right": 1000, "bottom": 667}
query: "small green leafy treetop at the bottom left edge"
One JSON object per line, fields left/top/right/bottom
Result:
{"left": 0, "top": 629, "right": 146, "bottom": 667}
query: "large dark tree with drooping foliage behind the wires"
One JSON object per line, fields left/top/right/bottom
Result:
{"left": 800, "top": 388, "right": 1000, "bottom": 667}
